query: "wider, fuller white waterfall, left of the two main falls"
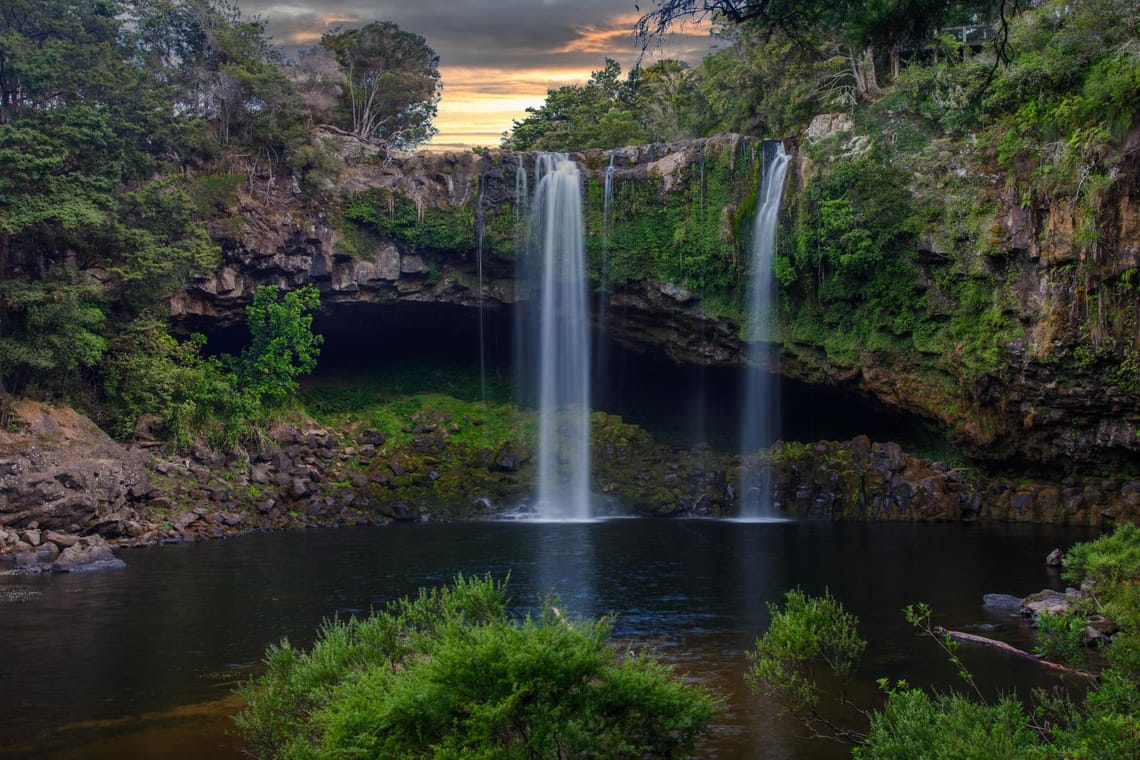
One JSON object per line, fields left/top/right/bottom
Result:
{"left": 520, "top": 154, "right": 591, "bottom": 520}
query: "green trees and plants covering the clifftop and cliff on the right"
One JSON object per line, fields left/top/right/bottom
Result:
{"left": 504, "top": 0, "right": 1140, "bottom": 428}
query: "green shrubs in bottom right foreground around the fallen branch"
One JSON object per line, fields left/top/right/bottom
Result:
{"left": 750, "top": 524, "right": 1140, "bottom": 760}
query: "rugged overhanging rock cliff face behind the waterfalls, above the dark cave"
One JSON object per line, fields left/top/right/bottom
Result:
{"left": 171, "top": 129, "right": 1140, "bottom": 467}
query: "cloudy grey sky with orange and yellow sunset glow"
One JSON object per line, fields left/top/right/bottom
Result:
{"left": 237, "top": 0, "right": 713, "bottom": 149}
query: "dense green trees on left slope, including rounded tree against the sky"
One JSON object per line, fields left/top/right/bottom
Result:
{"left": 0, "top": 0, "right": 439, "bottom": 441}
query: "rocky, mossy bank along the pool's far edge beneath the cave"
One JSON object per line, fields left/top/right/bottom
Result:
{"left": 0, "top": 402, "right": 1140, "bottom": 572}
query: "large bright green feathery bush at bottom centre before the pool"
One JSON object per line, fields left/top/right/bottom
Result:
{"left": 236, "top": 577, "right": 716, "bottom": 759}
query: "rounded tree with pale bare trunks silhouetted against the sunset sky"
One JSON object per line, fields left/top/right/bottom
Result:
{"left": 320, "top": 22, "right": 441, "bottom": 149}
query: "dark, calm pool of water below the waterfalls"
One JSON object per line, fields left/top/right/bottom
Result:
{"left": 0, "top": 520, "right": 1091, "bottom": 760}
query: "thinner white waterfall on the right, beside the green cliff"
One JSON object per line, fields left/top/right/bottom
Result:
{"left": 740, "top": 142, "right": 789, "bottom": 517}
